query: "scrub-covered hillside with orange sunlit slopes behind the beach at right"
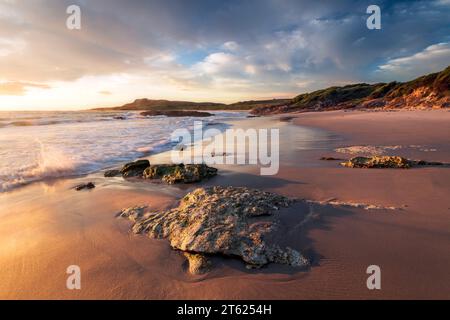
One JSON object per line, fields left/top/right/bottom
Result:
{"left": 252, "top": 66, "right": 450, "bottom": 115}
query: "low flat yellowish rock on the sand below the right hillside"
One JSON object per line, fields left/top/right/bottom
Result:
{"left": 341, "top": 156, "right": 414, "bottom": 169}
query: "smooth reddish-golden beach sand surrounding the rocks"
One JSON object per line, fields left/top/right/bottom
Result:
{"left": 0, "top": 111, "right": 450, "bottom": 299}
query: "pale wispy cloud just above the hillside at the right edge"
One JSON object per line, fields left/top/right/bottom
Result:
{"left": 378, "top": 43, "right": 450, "bottom": 79}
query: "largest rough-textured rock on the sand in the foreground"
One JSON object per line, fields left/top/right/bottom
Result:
{"left": 119, "top": 187, "right": 308, "bottom": 269}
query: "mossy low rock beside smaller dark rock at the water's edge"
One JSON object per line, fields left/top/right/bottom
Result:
{"left": 143, "top": 164, "right": 217, "bottom": 184}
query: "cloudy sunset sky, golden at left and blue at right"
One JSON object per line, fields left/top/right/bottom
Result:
{"left": 0, "top": 0, "right": 450, "bottom": 111}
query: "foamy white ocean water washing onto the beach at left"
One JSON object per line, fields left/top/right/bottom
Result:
{"left": 0, "top": 111, "right": 247, "bottom": 192}
